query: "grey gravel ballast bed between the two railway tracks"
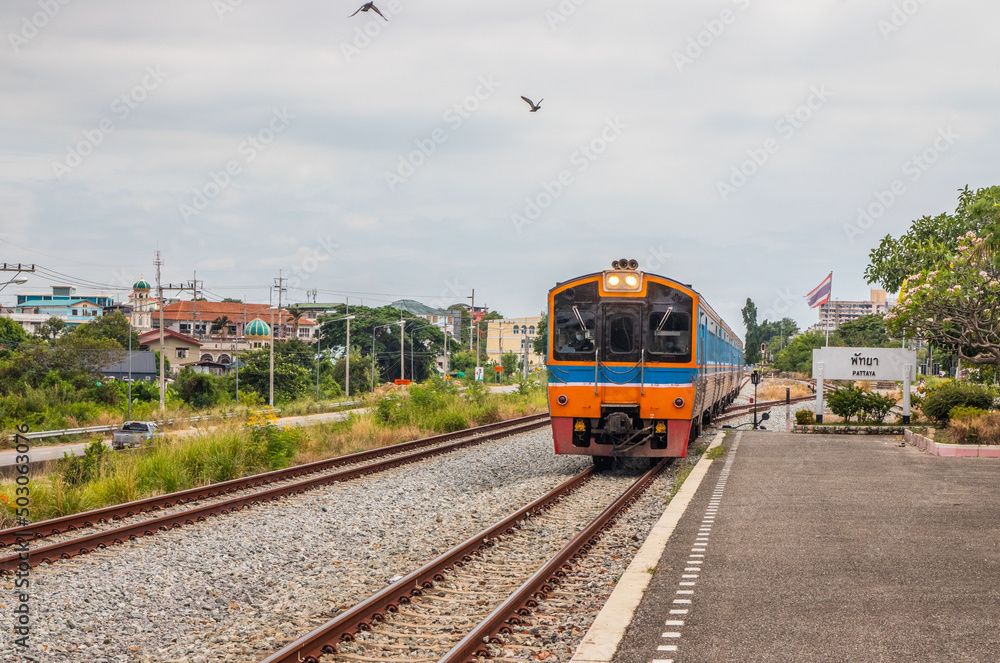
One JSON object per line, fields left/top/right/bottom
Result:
{"left": 0, "top": 429, "right": 590, "bottom": 663}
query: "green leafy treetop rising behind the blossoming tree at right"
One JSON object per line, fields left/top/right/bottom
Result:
{"left": 865, "top": 186, "right": 1000, "bottom": 292}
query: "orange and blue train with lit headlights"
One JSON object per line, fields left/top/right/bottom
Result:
{"left": 546, "top": 259, "right": 744, "bottom": 468}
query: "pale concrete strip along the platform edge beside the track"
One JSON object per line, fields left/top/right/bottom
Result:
{"left": 570, "top": 431, "right": 726, "bottom": 663}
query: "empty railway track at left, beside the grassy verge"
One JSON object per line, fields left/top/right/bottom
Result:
{"left": 0, "top": 413, "right": 548, "bottom": 574}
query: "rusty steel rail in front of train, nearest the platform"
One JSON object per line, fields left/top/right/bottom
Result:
{"left": 438, "top": 459, "right": 673, "bottom": 663}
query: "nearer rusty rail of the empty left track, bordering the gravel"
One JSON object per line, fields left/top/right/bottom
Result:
{"left": 0, "top": 420, "right": 548, "bottom": 574}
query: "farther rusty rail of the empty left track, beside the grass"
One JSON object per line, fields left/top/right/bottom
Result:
{"left": 0, "top": 413, "right": 548, "bottom": 549}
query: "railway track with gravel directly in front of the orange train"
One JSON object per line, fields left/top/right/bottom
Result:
{"left": 264, "top": 460, "right": 669, "bottom": 663}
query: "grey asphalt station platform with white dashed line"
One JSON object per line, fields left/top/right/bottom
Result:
{"left": 573, "top": 432, "right": 1000, "bottom": 663}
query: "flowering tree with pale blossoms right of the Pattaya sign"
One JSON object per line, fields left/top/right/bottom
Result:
{"left": 885, "top": 230, "right": 1000, "bottom": 367}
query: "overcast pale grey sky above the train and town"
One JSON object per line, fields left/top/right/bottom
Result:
{"left": 0, "top": 0, "right": 1000, "bottom": 342}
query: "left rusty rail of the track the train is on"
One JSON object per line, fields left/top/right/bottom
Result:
{"left": 262, "top": 467, "right": 594, "bottom": 663}
